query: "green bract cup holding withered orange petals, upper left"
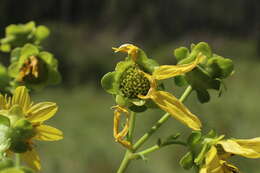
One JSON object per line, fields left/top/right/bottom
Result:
{"left": 8, "top": 44, "right": 61, "bottom": 89}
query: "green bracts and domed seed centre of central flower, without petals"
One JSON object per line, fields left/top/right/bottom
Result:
{"left": 101, "top": 49, "right": 159, "bottom": 112}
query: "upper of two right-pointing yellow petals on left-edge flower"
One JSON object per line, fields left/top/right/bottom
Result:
{"left": 26, "top": 102, "right": 58, "bottom": 123}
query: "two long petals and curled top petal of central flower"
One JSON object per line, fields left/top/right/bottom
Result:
{"left": 113, "top": 44, "right": 203, "bottom": 130}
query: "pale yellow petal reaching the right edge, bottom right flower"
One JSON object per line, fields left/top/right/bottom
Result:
{"left": 218, "top": 139, "right": 260, "bottom": 158}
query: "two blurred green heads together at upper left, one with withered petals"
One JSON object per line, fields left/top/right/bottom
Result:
{"left": 0, "top": 22, "right": 61, "bottom": 92}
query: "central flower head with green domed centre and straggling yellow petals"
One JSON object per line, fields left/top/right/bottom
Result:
{"left": 101, "top": 44, "right": 203, "bottom": 147}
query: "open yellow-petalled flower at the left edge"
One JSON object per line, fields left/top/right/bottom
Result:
{"left": 0, "top": 86, "right": 63, "bottom": 170}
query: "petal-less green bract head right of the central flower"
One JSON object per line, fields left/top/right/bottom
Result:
{"left": 174, "top": 42, "right": 234, "bottom": 103}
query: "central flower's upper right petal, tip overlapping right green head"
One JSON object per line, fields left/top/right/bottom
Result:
{"left": 153, "top": 54, "right": 202, "bottom": 80}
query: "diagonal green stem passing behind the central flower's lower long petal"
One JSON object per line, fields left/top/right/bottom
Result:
{"left": 133, "top": 86, "right": 192, "bottom": 151}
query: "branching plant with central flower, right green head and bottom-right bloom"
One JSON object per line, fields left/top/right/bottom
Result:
{"left": 101, "top": 42, "right": 260, "bottom": 173}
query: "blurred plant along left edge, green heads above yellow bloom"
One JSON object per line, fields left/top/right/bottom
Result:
{"left": 0, "top": 22, "right": 63, "bottom": 173}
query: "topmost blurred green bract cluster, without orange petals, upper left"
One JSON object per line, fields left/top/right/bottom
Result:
{"left": 0, "top": 21, "right": 50, "bottom": 52}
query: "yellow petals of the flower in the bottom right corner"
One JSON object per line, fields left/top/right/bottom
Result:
{"left": 200, "top": 137, "right": 260, "bottom": 173}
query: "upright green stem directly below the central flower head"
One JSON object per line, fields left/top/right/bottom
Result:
{"left": 117, "top": 112, "right": 136, "bottom": 173}
